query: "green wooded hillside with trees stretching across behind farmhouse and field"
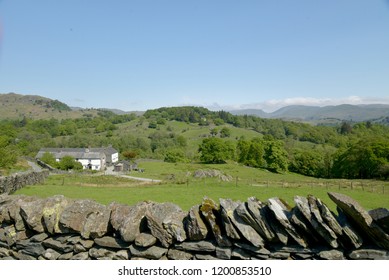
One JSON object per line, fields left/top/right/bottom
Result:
{"left": 0, "top": 107, "right": 389, "bottom": 179}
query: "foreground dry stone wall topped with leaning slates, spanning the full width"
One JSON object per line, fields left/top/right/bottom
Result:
{"left": 0, "top": 193, "right": 389, "bottom": 260}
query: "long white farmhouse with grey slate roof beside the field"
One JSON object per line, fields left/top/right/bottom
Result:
{"left": 36, "top": 146, "right": 119, "bottom": 170}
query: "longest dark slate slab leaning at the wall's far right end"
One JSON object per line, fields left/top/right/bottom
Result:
{"left": 328, "top": 192, "right": 389, "bottom": 250}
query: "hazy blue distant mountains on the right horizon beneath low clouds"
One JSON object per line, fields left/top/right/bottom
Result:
{"left": 230, "top": 104, "right": 389, "bottom": 123}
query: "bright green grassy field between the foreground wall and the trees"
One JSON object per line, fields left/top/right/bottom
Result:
{"left": 16, "top": 162, "right": 389, "bottom": 210}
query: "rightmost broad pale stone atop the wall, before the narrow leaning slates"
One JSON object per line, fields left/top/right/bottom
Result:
{"left": 146, "top": 203, "right": 186, "bottom": 248}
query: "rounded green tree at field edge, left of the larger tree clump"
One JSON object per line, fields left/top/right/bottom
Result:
{"left": 199, "top": 137, "right": 235, "bottom": 163}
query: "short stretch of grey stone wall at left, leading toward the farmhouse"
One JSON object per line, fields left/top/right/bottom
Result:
{"left": 0, "top": 170, "right": 49, "bottom": 194}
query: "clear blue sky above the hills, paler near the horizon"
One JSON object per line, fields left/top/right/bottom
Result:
{"left": 0, "top": 0, "right": 389, "bottom": 111}
